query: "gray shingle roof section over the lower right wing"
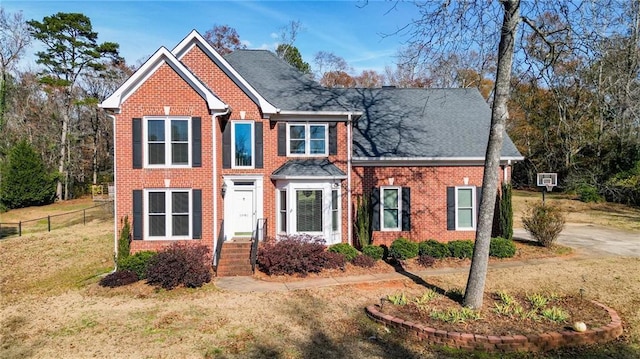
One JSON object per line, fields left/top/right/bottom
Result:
{"left": 348, "top": 88, "right": 521, "bottom": 158}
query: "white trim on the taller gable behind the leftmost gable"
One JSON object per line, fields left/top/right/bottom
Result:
{"left": 171, "top": 30, "right": 278, "bottom": 114}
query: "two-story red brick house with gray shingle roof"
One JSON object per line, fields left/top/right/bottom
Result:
{"left": 100, "top": 31, "right": 523, "bottom": 262}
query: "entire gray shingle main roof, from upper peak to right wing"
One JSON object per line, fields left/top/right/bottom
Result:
{"left": 225, "top": 50, "right": 521, "bottom": 159}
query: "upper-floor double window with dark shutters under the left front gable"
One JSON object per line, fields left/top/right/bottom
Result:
{"left": 143, "top": 117, "right": 192, "bottom": 167}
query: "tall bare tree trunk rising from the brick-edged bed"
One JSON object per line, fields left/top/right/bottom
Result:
{"left": 463, "top": 0, "right": 520, "bottom": 309}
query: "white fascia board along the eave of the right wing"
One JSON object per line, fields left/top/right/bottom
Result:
{"left": 352, "top": 157, "right": 524, "bottom": 167}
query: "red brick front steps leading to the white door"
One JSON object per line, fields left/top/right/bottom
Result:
{"left": 216, "top": 238, "right": 253, "bottom": 277}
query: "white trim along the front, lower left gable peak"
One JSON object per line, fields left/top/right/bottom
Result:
{"left": 98, "top": 46, "right": 229, "bottom": 111}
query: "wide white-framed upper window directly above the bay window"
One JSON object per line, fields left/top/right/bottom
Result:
{"left": 287, "top": 123, "right": 329, "bottom": 156}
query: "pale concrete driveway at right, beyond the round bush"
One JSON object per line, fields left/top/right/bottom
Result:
{"left": 513, "top": 223, "right": 640, "bottom": 257}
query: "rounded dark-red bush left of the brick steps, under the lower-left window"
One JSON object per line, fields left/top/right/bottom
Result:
{"left": 147, "top": 243, "right": 211, "bottom": 289}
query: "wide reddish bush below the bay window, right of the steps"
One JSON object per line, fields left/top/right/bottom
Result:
{"left": 257, "top": 234, "right": 330, "bottom": 276}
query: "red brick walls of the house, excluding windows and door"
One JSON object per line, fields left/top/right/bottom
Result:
{"left": 107, "top": 33, "right": 502, "bottom": 252}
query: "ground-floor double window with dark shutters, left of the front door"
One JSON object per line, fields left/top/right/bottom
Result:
{"left": 145, "top": 189, "right": 193, "bottom": 239}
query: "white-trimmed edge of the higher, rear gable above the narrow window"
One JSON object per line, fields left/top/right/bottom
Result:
{"left": 171, "top": 30, "right": 278, "bottom": 114}
